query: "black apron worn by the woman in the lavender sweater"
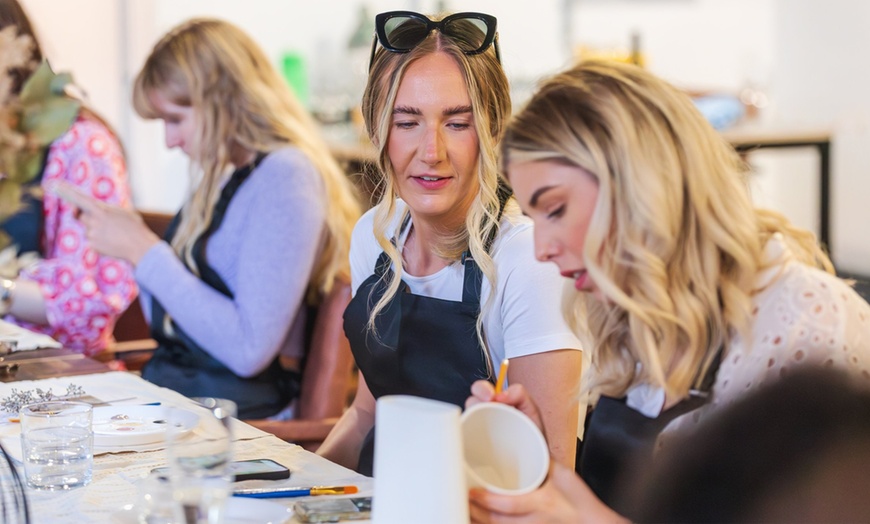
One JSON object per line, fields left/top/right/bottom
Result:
{"left": 142, "top": 154, "right": 301, "bottom": 419}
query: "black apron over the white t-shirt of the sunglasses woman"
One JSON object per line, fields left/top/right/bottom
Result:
{"left": 344, "top": 220, "right": 498, "bottom": 476}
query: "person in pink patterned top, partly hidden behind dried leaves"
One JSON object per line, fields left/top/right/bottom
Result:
{"left": 0, "top": 0, "right": 137, "bottom": 355}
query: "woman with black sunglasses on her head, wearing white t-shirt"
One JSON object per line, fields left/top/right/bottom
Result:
{"left": 318, "top": 12, "right": 581, "bottom": 475}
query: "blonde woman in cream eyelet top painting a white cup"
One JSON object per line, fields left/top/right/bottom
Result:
{"left": 468, "top": 62, "right": 870, "bottom": 523}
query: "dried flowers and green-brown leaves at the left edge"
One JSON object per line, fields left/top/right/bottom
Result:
{"left": 0, "top": 26, "right": 81, "bottom": 248}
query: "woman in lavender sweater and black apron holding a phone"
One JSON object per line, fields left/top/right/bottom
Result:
{"left": 65, "top": 19, "right": 359, "bottom": 418}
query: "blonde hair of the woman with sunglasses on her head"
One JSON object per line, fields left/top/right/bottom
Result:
{"left": 362, "top": 12, "right": 510, "bottom": 366}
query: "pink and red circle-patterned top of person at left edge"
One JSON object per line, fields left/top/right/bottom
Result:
{"left": 10, "top": 117, "right": 137, "bottom": 355}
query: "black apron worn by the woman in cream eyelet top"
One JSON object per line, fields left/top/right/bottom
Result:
{"left": 578, "top": 350, "right": 722, "bottom": 519}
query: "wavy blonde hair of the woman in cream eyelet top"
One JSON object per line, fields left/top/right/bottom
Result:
{"left": 502, "top": 61, "right": 833, "bottom": 398}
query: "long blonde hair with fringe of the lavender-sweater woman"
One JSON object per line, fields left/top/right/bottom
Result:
{"left": 133, "top": 19, "right": 360, "bottom": 300}
